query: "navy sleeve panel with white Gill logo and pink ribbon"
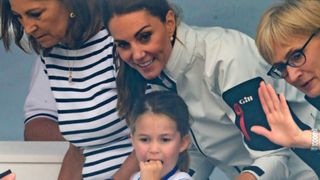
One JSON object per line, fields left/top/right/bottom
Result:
{"left": 222, "top": 77, "right": 280, "bottom": 150}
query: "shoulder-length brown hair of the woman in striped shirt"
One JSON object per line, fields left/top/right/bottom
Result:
{"left": 0, "top": 0, "right": 102, "bottom": 54}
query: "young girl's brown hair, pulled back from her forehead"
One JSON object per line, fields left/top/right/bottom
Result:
{"left": 127, "top": 91, "right": 190, "bottom": 172}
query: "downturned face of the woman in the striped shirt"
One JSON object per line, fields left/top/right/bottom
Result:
{"left": 9, "top": 0, "right": 69, "bottom": 48}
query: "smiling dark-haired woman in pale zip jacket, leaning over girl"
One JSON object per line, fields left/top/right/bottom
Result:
{"left": 103, "top": 0, "right": 316, "bottom": 180}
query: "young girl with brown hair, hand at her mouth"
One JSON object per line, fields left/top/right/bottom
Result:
{"left": 128, "top": 91, "right": 192, "bottom": 180}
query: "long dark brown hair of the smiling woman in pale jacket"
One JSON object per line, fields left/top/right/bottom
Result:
{"left": 102, "top": 0, "right": 177, "bottom": 117}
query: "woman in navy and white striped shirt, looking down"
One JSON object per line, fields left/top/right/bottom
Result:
{"left": 1, "top": 0, "right": 135, "bottom": 180}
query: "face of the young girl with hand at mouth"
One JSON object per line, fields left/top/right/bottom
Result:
{"left": 132, "top": 112, "right": 190, "bottom": 177}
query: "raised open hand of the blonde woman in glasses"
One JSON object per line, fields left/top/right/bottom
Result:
{"left": 251, "top": 82, "right": 303, "bottom": 147}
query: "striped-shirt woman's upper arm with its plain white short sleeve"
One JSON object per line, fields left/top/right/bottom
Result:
{"left": 24, "top": 57, "right": 64, "bottom": 141}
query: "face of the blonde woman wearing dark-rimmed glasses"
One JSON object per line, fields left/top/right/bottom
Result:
{"left": 274, "top": 33, "right": 320, "bottom": 97}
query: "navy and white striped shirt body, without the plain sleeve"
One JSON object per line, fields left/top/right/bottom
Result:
{"left": 26, "top": 30, "right": 132, "bottom": 179}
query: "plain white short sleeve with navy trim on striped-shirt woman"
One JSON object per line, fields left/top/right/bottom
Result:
{"left": 24, "top": 57, "right": 58, "bottom": 124}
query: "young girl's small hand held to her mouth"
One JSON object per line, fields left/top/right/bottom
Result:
{"left": 139, "top": 161, "right": 163, "bottom": 180}
